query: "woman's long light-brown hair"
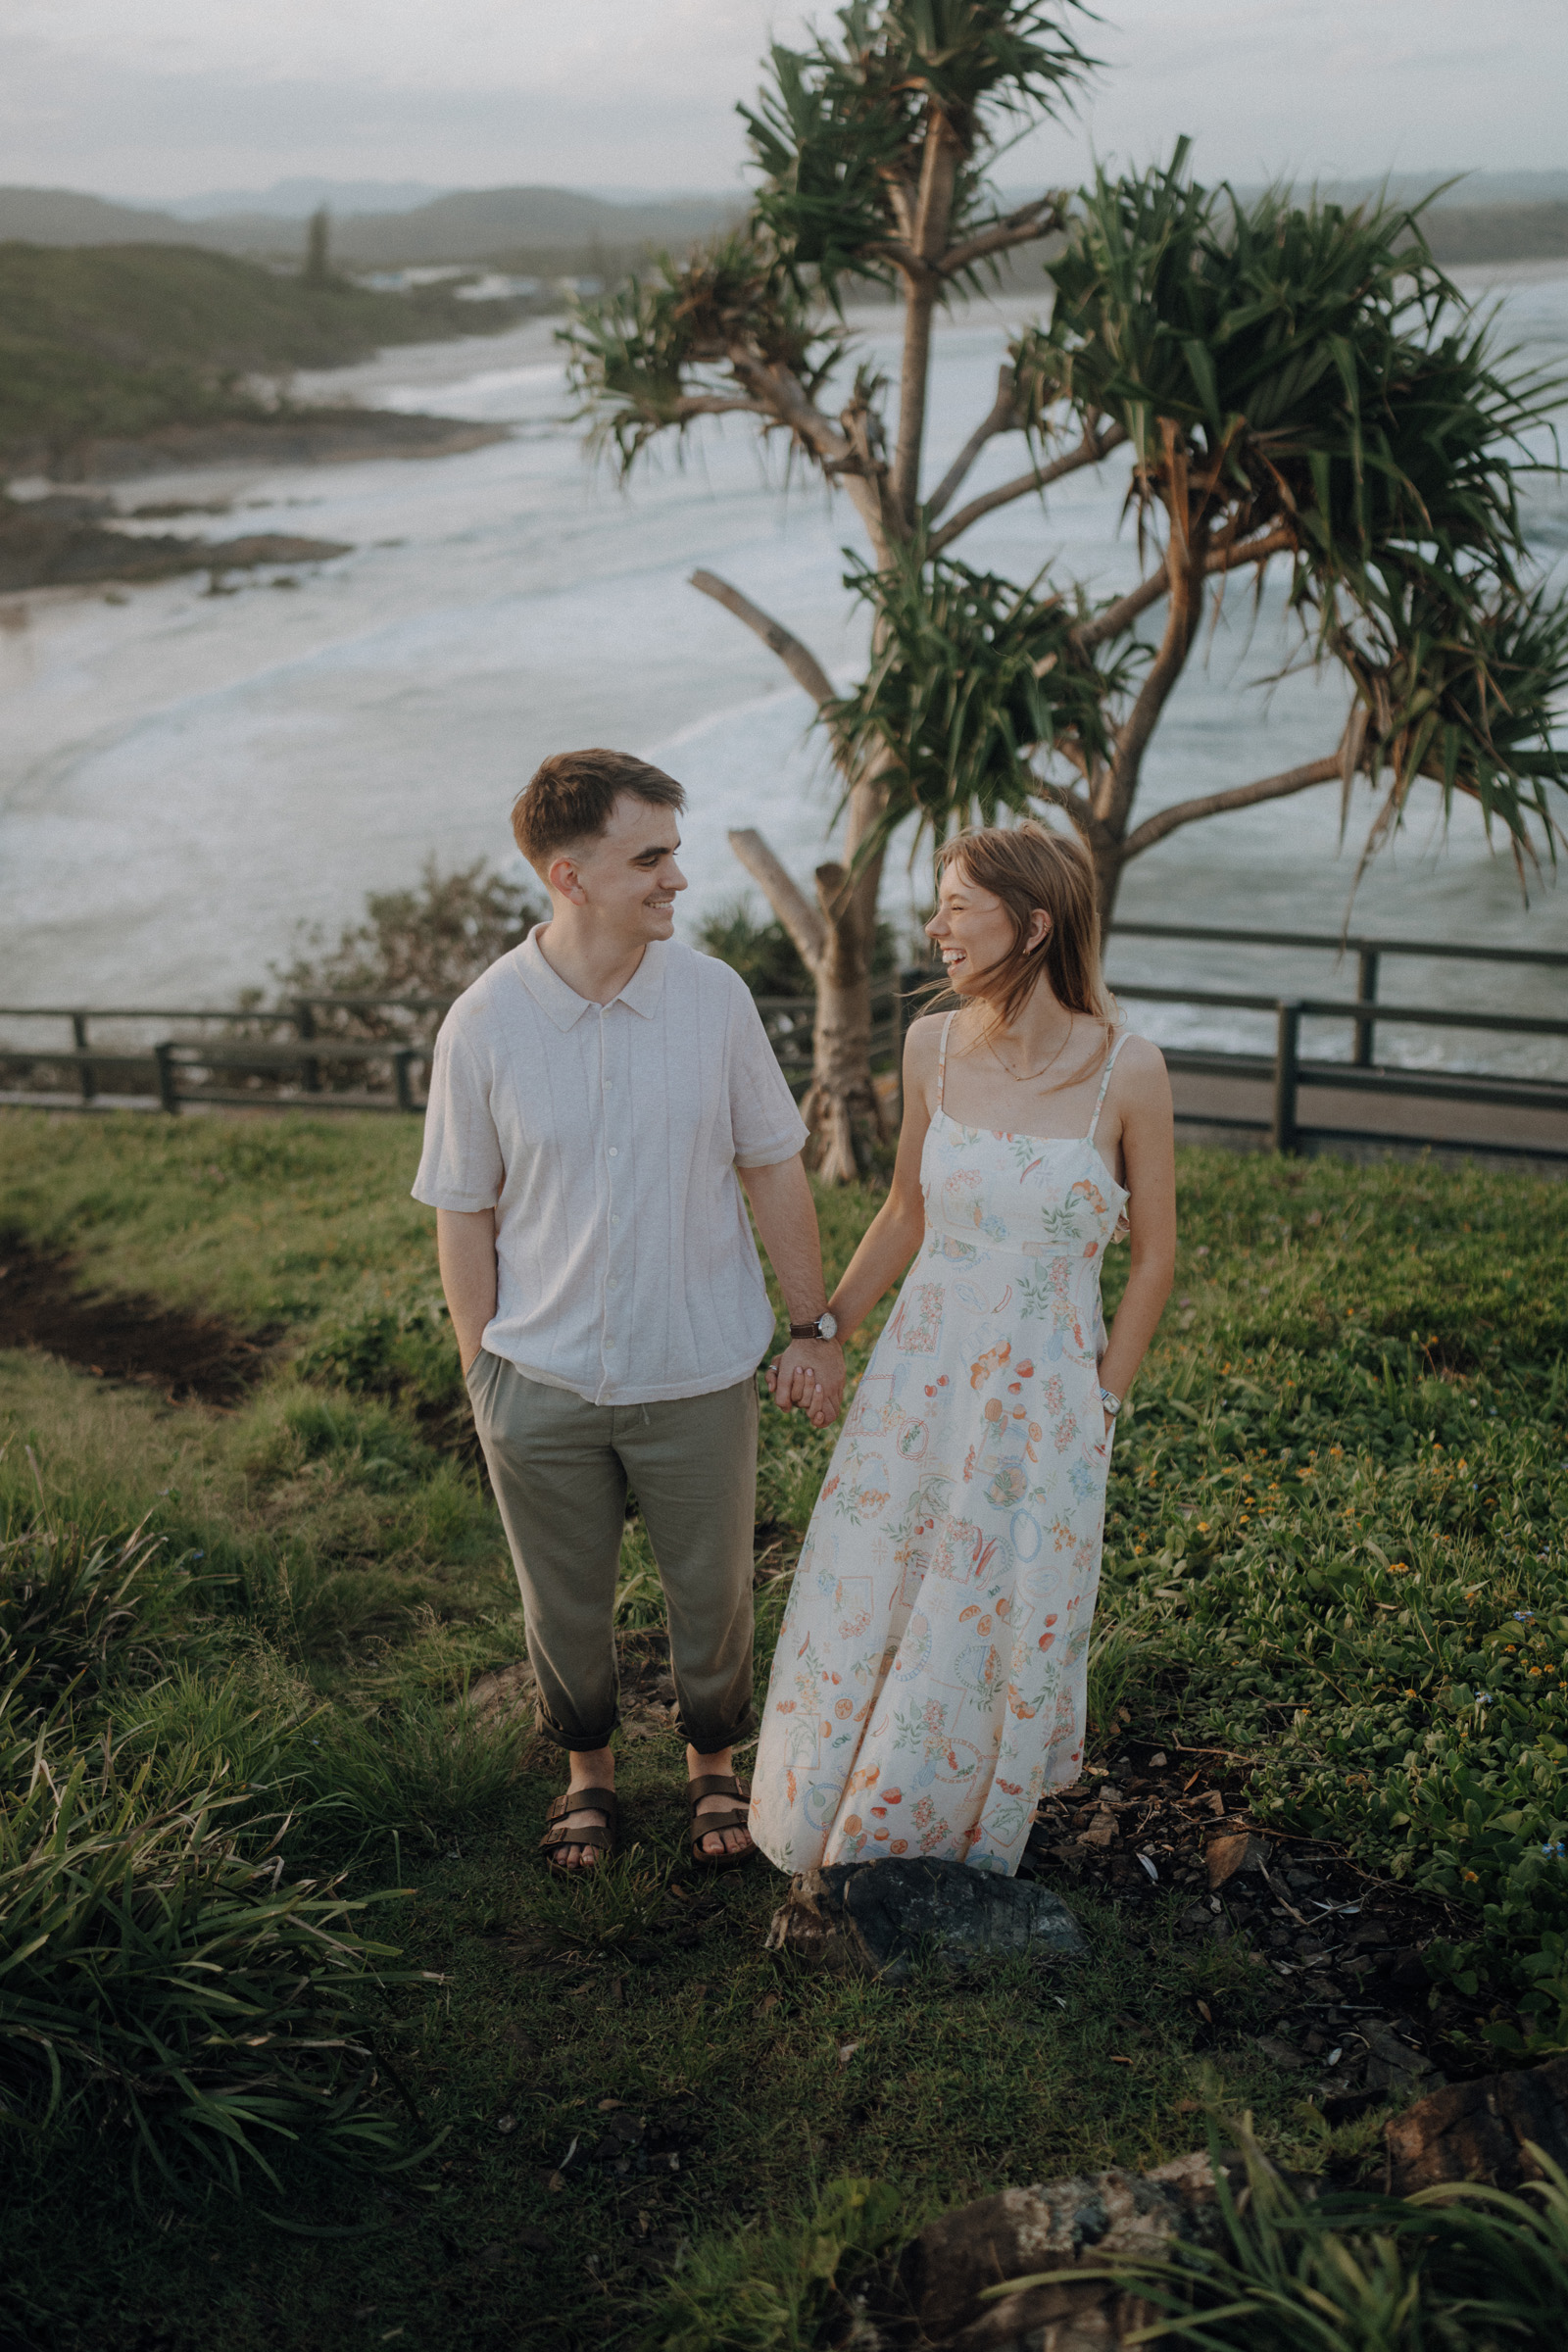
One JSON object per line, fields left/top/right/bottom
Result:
{"left": 936, "top": 821, "right": 1119, "bottom": 1033}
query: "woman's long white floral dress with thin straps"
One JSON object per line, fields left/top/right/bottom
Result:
{"left": 753, "top": 1016, "right": 1128, "bottom": 1875}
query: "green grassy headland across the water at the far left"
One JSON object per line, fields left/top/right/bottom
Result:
{"left": 0, "top": 245, "right": 526, "bottom": 464}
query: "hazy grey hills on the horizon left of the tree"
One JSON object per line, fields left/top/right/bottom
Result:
{"left": 0, "top": 188, "right": 745, "bottom": 270}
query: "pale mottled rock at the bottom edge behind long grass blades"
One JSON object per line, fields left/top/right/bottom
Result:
{"left": 901, "top": 2154, "right": 1218, "bottom": 2352}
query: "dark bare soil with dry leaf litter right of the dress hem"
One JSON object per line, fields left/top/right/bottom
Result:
{"left": 1022, "top": 1742, "right": 1499, "bottom": 2124}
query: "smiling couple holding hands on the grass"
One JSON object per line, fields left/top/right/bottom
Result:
{"left": 414, "top": 751, "right": 1175, "bottom": 1875}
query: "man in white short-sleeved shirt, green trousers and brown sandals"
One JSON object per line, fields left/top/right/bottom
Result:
{"left": 414, "top": 751, "right": 844, "bottom": 1870}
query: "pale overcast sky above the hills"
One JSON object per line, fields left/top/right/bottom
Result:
{"left": 0, "top": 0, "right": 1568, "bottom": 200}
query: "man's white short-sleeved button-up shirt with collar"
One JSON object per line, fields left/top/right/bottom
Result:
{"left": 414, "top": 934, "right": 807, "bottom": 1404}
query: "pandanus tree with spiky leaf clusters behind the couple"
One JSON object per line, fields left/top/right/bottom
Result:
{"left": 566, "top": 0, "right": 1568, "bottom": 1181}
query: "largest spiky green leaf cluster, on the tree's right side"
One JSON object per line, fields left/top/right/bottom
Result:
{"left": 1044, "top": 141, "right": 1561, "bottom": 571}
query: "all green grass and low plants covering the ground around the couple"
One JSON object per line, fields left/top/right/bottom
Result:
{"left": 0, "top": 1105, "right": 1568, "bottom": 2352}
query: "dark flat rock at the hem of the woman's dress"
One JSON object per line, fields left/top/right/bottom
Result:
{"left": 766, "top": 1860, "right": 1086, "bottom": 1985}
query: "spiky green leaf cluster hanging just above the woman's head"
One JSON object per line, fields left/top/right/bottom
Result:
{"left": 823, "top": 546, "right": 1145, "bottom": 842}
